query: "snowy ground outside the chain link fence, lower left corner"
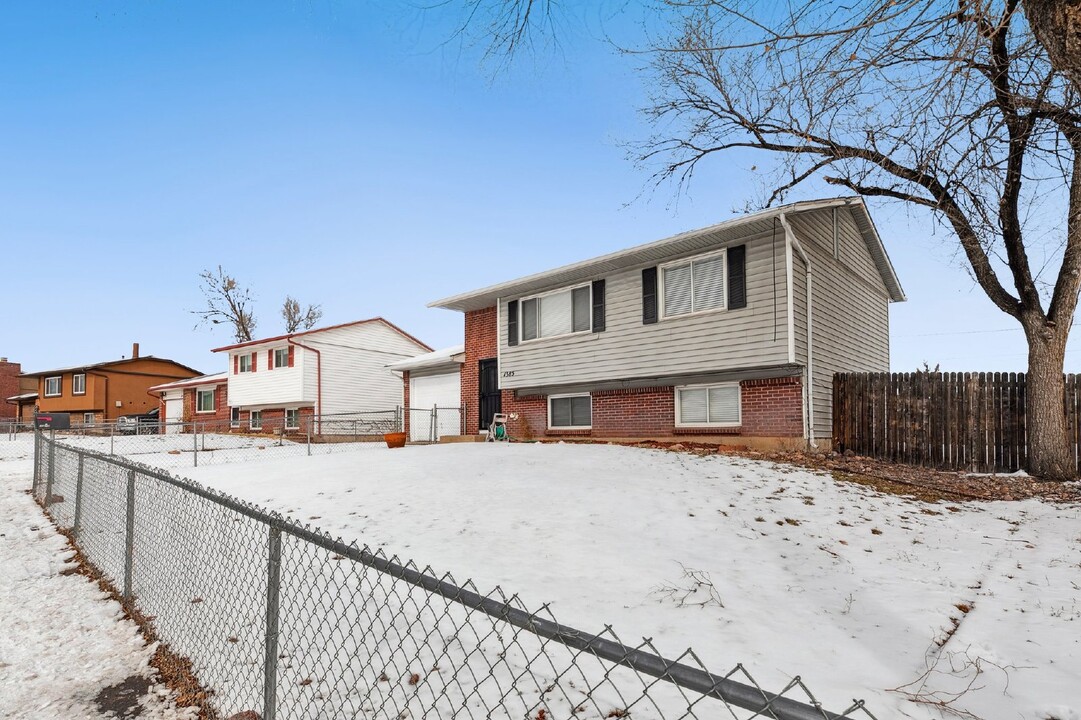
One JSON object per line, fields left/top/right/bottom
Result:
{"left": 0, "top": 436, "right": 193, "bottom": 720}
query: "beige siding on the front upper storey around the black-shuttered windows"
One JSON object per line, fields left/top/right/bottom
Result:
{"left": 499, "top": 224, "right": 788, "bottom": 389}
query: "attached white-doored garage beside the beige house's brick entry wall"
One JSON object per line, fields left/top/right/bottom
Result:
{"left": 389, "top": 345, "right": 466, "bottom": 442}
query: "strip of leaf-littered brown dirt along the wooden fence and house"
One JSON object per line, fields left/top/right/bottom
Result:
{"left": 609, "top": 440, "right": 1081, "bottom": 504}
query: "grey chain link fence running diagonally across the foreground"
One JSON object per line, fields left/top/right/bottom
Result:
{"left": 34, "top": 432, "right": 873, "bottom": 720}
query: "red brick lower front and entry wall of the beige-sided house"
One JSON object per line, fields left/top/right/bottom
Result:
{"left": 460, "top": 307, "right": 803, "bottom": 441}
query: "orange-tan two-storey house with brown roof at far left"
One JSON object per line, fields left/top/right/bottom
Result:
{"left": 23, "top": 343, "right": 199, "bottom": 425}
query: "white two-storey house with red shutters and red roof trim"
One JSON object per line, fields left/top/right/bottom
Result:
{"left": 214, "top": 318, "right": 431, "bottom": 432}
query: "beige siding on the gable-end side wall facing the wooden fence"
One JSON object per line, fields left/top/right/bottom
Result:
{"left": 789, "top": 209, "right": 890, "bottom": 438}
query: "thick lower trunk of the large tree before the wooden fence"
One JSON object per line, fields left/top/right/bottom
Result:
{"left": 1025, "top": 330, "right": 1077, "bottom": 480}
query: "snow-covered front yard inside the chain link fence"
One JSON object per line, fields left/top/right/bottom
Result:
{"left": 172, "top": 436, "right": 1081, "bottom": 720}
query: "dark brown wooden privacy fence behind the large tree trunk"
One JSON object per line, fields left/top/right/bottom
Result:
{"left": 833, "top": 372, "right": 1081, "bottom": 472}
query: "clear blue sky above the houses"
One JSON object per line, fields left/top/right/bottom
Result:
{"left": 0, "top": 0, "right": 1081, "bottom": 372}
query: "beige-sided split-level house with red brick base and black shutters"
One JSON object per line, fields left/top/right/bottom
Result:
{"left": 429, "top": 193, "right": 905, "bottom": 445}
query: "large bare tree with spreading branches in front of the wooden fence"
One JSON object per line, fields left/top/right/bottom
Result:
{"left": 458, "top": 0, "right": 1081, "bottom": 479}
